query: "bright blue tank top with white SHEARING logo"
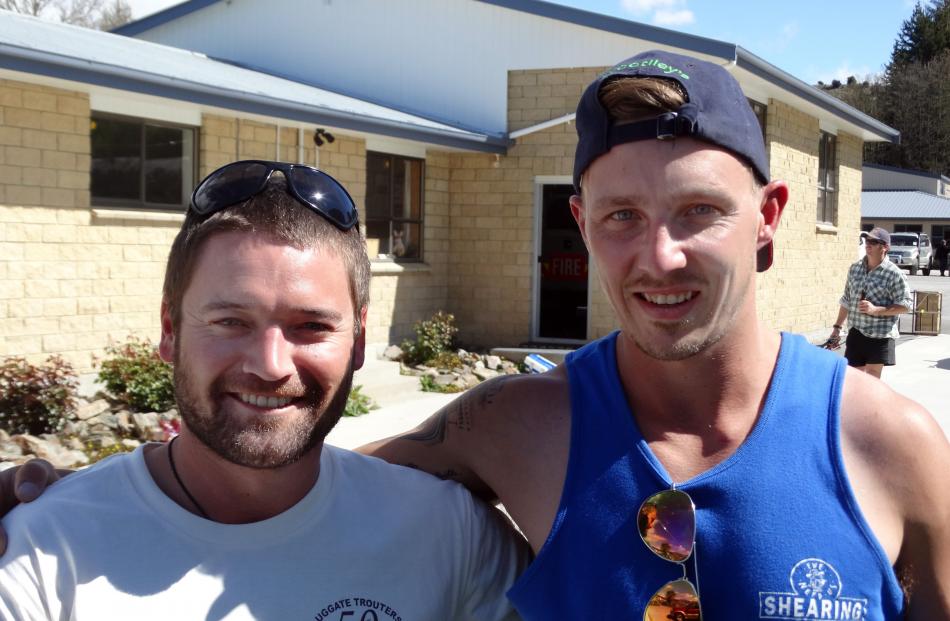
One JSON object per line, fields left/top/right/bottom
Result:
{"left": 508, "top": 333, "right": 904, "bottom": 621}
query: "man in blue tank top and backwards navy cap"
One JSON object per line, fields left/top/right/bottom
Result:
{"left": 7, "top": 51, "right": 950, "bottom": 621}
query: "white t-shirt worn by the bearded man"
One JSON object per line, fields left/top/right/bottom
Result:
{"left": 0, "top": 446, "right": 529, "bottom": 621}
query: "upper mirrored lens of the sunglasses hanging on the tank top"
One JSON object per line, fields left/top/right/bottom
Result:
{"left": 637, "top": 490, "right": 696, "bottom": 563}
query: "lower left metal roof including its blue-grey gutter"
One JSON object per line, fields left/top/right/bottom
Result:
{"left": 0, "top": 12, "right": 508, "bottom": 153}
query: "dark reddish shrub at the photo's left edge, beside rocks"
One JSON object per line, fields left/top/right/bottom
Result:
{"left": 0, "top": 356, "right": 79, "bottom": 435}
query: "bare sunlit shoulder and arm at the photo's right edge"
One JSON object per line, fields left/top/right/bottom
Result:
{"left": 841, "top": 371, "right": 950, "bottom": 620}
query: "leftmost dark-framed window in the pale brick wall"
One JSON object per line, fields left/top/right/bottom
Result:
{"left": 90, "top": 113, "right": 195, "bottom": 209}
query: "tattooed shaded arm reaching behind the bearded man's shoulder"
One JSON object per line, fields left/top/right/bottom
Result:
{"left": 359, "top": 365, "right": 571, "bottom": 551}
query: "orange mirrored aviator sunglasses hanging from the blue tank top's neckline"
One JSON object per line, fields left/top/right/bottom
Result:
{"left": 637, "top": 489, "right": 702, "bottom": 621}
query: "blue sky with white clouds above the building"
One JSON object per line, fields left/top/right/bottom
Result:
{"left": 127, "top": 0, "right": 916, "bottom": 84}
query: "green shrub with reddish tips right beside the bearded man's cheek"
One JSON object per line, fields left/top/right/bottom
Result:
{"left": 99, "top": 337, "right": 175, "bottom": 412}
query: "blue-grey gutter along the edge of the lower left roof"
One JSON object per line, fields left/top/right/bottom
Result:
{"left": 0, "top": 44, "right": 509, "bottom": 154}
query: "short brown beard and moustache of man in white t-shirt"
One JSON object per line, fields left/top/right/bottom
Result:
{"left": 173, "top": 349, "right": 353, "bottom": 469}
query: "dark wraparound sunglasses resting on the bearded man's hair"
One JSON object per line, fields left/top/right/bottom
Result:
{"left": 191, "top": 160, "right": 358, "bottom": 231}
